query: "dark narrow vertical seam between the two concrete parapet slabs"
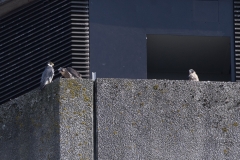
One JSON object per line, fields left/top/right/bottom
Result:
{"left": 93, "top": 79, "right": 98, "bottom": 160}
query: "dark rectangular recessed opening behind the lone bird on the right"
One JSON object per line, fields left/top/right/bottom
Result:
{"left": 147, "top": 35, "right": 231, "bottom": 81}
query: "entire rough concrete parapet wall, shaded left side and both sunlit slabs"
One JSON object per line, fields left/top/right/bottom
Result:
{"left": 0, "top": 79, "right": 240, "bottom": 160}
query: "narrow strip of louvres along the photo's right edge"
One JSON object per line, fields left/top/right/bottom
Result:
{"left": 233, "top": 0, "right": 240, "bottom": 81}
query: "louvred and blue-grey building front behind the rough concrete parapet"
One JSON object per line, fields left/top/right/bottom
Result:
{"left": 0, "top": 0, "right": 240, "bottom": 103}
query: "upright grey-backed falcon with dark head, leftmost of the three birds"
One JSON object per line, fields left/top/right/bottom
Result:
{"left": 40, "top": 62, "right": 54, "bottom": 90}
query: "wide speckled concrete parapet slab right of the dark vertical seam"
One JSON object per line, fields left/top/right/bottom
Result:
{"left": 96, "top": 79, "right": 240, "bottom": 160}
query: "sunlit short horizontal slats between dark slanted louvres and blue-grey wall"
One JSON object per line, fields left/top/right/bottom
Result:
{"left": 71, "top": 0, "right": 89, "bottom": 78}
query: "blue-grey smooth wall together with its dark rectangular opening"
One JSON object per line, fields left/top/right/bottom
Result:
{"left": 89, "top": 0, "right": 236, "bottom": 81}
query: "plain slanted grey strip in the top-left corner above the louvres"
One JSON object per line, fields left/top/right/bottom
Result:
{"left": 0, "top": 0, "right": 35, "bottom": 17}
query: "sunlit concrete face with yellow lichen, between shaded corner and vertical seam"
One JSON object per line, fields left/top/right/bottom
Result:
{"left": 59, "top": 79, "right": 93, "bottom": 160}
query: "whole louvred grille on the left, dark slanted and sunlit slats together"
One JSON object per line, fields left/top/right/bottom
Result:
{"left": 0, "top": 0, "right": 89, "bottom": 104}
